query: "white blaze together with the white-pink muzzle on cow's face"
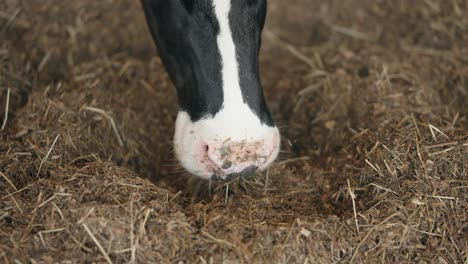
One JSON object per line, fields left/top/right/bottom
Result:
{"left": 174, "top": 0, "right": 280, "bottom": 178}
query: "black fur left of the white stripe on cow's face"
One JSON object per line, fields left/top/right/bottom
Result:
{"left": 141, "top": 0, "right": 223, "bottom": 121}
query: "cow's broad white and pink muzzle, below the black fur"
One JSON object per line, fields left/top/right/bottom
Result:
{"left": 174, "top": 110, "right": 280, "bottom": 179}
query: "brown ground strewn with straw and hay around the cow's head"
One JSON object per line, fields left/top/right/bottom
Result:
{"left": 0, "top": 0, "right": 468, "bottom": 263}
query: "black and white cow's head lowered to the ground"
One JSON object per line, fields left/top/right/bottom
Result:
{"left": 141, "top": 0, "right": 280, "bottom": 180}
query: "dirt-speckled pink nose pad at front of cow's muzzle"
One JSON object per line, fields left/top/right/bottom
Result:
{"left": 207, "top": 141, "right": 273, "bottom": 178}
